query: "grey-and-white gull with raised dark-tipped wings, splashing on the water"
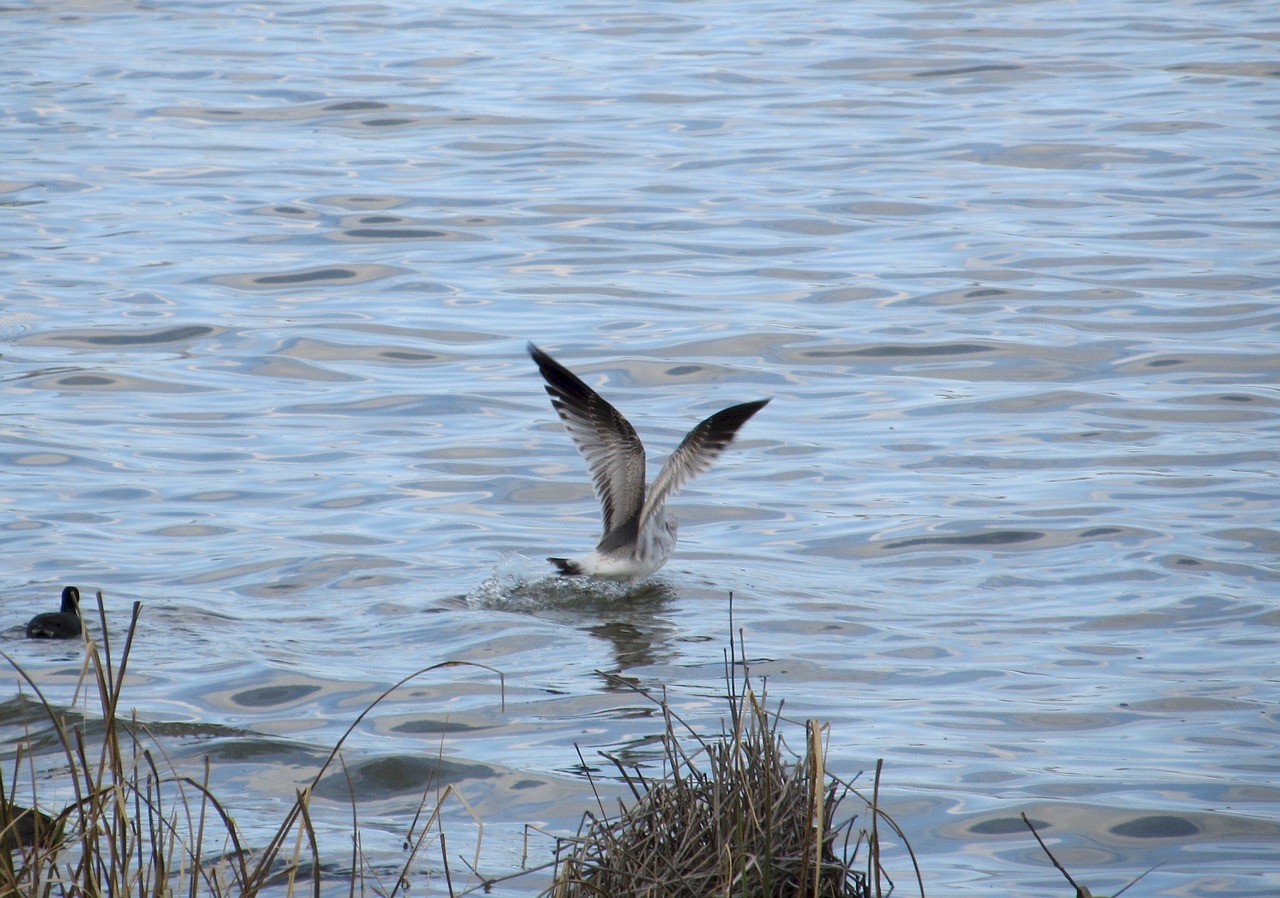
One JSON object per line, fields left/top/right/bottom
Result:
{"left": 529, "top": 343, "right": 769, "bottom": 582}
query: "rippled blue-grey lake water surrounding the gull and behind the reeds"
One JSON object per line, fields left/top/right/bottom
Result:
{"left": 0, "top": 0, "right": 1280, "bottom": 897}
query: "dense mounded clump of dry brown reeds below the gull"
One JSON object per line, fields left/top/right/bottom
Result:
{"left": 544, "top": 642, "right": 924, "bottom": 898}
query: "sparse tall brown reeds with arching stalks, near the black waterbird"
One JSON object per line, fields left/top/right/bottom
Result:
{"left": 0, "top": 592, "right": 502, "bottom": 898}
